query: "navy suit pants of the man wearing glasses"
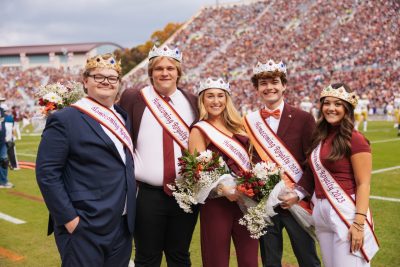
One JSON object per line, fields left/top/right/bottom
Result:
{"left": 54, "top": 216, "right": 132, "bottom": 267}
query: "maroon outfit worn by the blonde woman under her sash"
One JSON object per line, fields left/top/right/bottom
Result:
{"left": 200, "top": 134, "right": 258, "bottom": 267}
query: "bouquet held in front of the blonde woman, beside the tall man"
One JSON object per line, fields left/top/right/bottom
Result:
{"left": 168, "top": 150, "right": 228, "bottom": 213}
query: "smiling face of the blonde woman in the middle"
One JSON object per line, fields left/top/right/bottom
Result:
{"left": 203, "top": 88, "right": 226, "bottom": 119}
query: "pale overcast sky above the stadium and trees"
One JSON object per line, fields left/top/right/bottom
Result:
{"left": 0, "top": 0, "right": 239, "bottom": 47}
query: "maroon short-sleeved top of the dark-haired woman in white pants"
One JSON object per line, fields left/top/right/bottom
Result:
{"left": 314, "top": 127, "right": 371, "bottom": 198}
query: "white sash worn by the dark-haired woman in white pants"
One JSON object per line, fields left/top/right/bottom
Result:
{"left": 310, "top": 143, "right": 379, "bottom": 262}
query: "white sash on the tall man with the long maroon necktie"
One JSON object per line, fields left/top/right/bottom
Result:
{"left": 140, "top": 86, "right": 189, "bottom": 149}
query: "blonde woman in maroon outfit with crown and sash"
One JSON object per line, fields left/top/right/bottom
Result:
{"left": 189, "top": 78, "right": 258, "bottom": 267}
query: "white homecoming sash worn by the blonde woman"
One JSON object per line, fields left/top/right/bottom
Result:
{"left": 193, "top": 121, "right": 251, "bottom": 171}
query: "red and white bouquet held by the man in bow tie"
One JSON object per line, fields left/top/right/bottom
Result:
{"left": 237, "top": 161, "right": 282, "bottom": 239}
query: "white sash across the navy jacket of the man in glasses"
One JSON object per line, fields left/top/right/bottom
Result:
{"left": 71, "top": 97, "right": 133, "bottom": 158}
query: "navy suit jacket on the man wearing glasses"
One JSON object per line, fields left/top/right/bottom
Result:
{"left": 36, "top": 106, "right": 136, "bottom": 234}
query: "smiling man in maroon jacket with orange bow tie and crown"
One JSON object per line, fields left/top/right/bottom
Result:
{"left": 244, "top": 60, "right": 320, "bottom": 267}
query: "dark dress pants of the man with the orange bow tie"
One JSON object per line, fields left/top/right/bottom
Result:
{"left": 260, "top": 211, "right": 321, "bottom": 267}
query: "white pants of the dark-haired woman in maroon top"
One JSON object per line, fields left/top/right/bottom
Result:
{"left": 313, "top": 199, "right": 371, "bottom": 267}
